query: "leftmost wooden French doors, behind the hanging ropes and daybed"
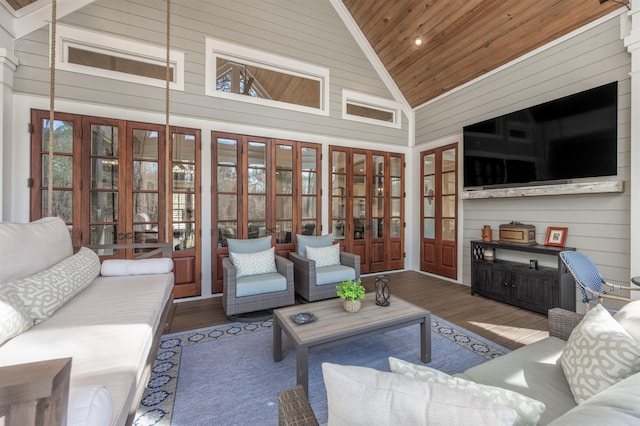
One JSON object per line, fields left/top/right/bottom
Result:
{"left": 31, "top": 111, "right": 201, "bottom": 297}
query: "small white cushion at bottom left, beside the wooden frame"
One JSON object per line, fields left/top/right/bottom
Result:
{"left": 67, "top": 386, "right": 113, "bottom": 426}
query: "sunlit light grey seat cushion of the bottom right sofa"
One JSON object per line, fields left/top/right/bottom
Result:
{"left": 456, "top": 337, "right": 576, "bottom": 425}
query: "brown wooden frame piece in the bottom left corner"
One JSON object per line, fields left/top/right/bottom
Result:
{"left": 0, "top": 358, "right": 71, "bottom": 426}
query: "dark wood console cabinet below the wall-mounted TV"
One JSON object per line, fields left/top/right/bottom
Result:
{"left": 471, "top": 241, "right": 576, "bottom": 315}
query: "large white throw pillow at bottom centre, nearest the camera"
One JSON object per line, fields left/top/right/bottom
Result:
{"left": 322, "top": 362, "right": 516, "bottom": 426}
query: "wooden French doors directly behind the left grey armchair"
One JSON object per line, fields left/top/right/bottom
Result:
{"left": 211, "top": 132, "right": 321, "bottom": 293}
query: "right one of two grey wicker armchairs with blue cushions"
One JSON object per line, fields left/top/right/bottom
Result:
{"left": 289, "top": 234, "right": 360, "bottom": 302}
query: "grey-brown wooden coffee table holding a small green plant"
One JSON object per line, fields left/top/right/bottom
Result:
{"left": 273, "top": 293, "right": 431, "bottom": 395}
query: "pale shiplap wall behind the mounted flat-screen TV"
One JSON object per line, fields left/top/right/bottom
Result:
{"left": 416, "top": 10, "right": 630, "bottom": 300}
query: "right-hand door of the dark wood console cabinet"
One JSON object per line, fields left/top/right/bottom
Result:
{"left": 511, "top": 266, "right": 559, "bottom": 314}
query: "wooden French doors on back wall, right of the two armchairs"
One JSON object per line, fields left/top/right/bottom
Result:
{"left": 329, "top": 146, "right": 404, "bottom": 273}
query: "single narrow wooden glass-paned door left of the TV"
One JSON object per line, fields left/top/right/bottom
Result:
{"left": 420, "top": 144, "right": 458, "bottom": 279}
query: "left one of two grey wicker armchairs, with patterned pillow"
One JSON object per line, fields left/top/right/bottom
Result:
{"left": 222, "top": 237, "right": 295, "bottom": 316}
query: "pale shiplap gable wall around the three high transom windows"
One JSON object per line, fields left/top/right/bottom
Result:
{"left": 11, "top": 0, "right": 408, "bottom": 146}
